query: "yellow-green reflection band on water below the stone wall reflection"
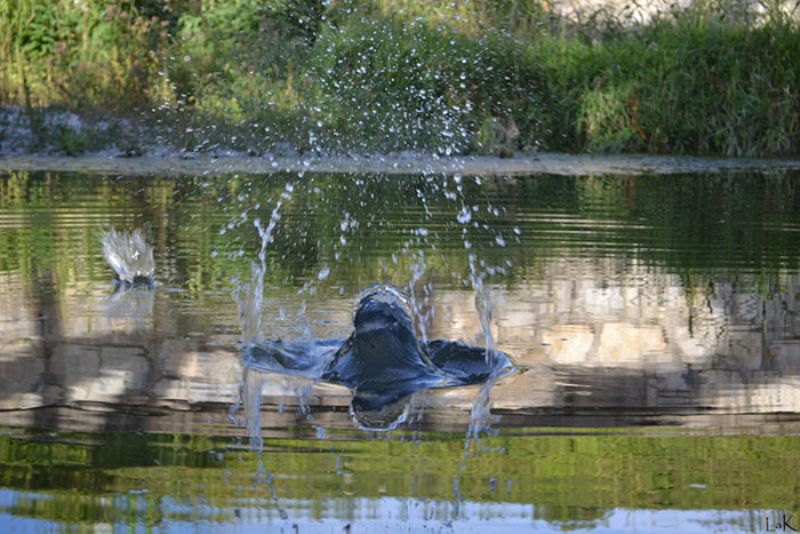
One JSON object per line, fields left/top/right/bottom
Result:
{"left": 0, "top": 433, "right": 800, "bottom": 526}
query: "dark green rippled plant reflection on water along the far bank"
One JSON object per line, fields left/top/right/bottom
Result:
{"left": 0, "top": 172, "right": 800, "bottom": 298}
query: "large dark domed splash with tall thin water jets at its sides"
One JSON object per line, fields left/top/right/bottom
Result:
{"left": 225, "top": 175, "right": 510, "bottom": 528}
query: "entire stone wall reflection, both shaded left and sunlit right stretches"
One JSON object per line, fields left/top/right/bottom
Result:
{"left": 0, "top": 258, "right": 800, "bottom": 436}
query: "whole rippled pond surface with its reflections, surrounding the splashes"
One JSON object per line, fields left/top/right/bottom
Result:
{"left": 0, "top": 170, "right": 800, "bottom": 532}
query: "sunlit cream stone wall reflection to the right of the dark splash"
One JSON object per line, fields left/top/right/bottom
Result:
{"left": 434, "top": 258, "right": 800, "bottom": 414}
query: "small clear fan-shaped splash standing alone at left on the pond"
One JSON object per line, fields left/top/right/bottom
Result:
{"left": 100, "top": 228, "right": 156, "bottom": 286}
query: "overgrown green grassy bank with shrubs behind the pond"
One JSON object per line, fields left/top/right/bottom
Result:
{"left": 0, "top": 0, "right": 800, "bottom": 156}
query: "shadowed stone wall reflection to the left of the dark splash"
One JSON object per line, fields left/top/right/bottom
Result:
{"left": 0, "top": 273, "right": 349, "bottom": 432}
